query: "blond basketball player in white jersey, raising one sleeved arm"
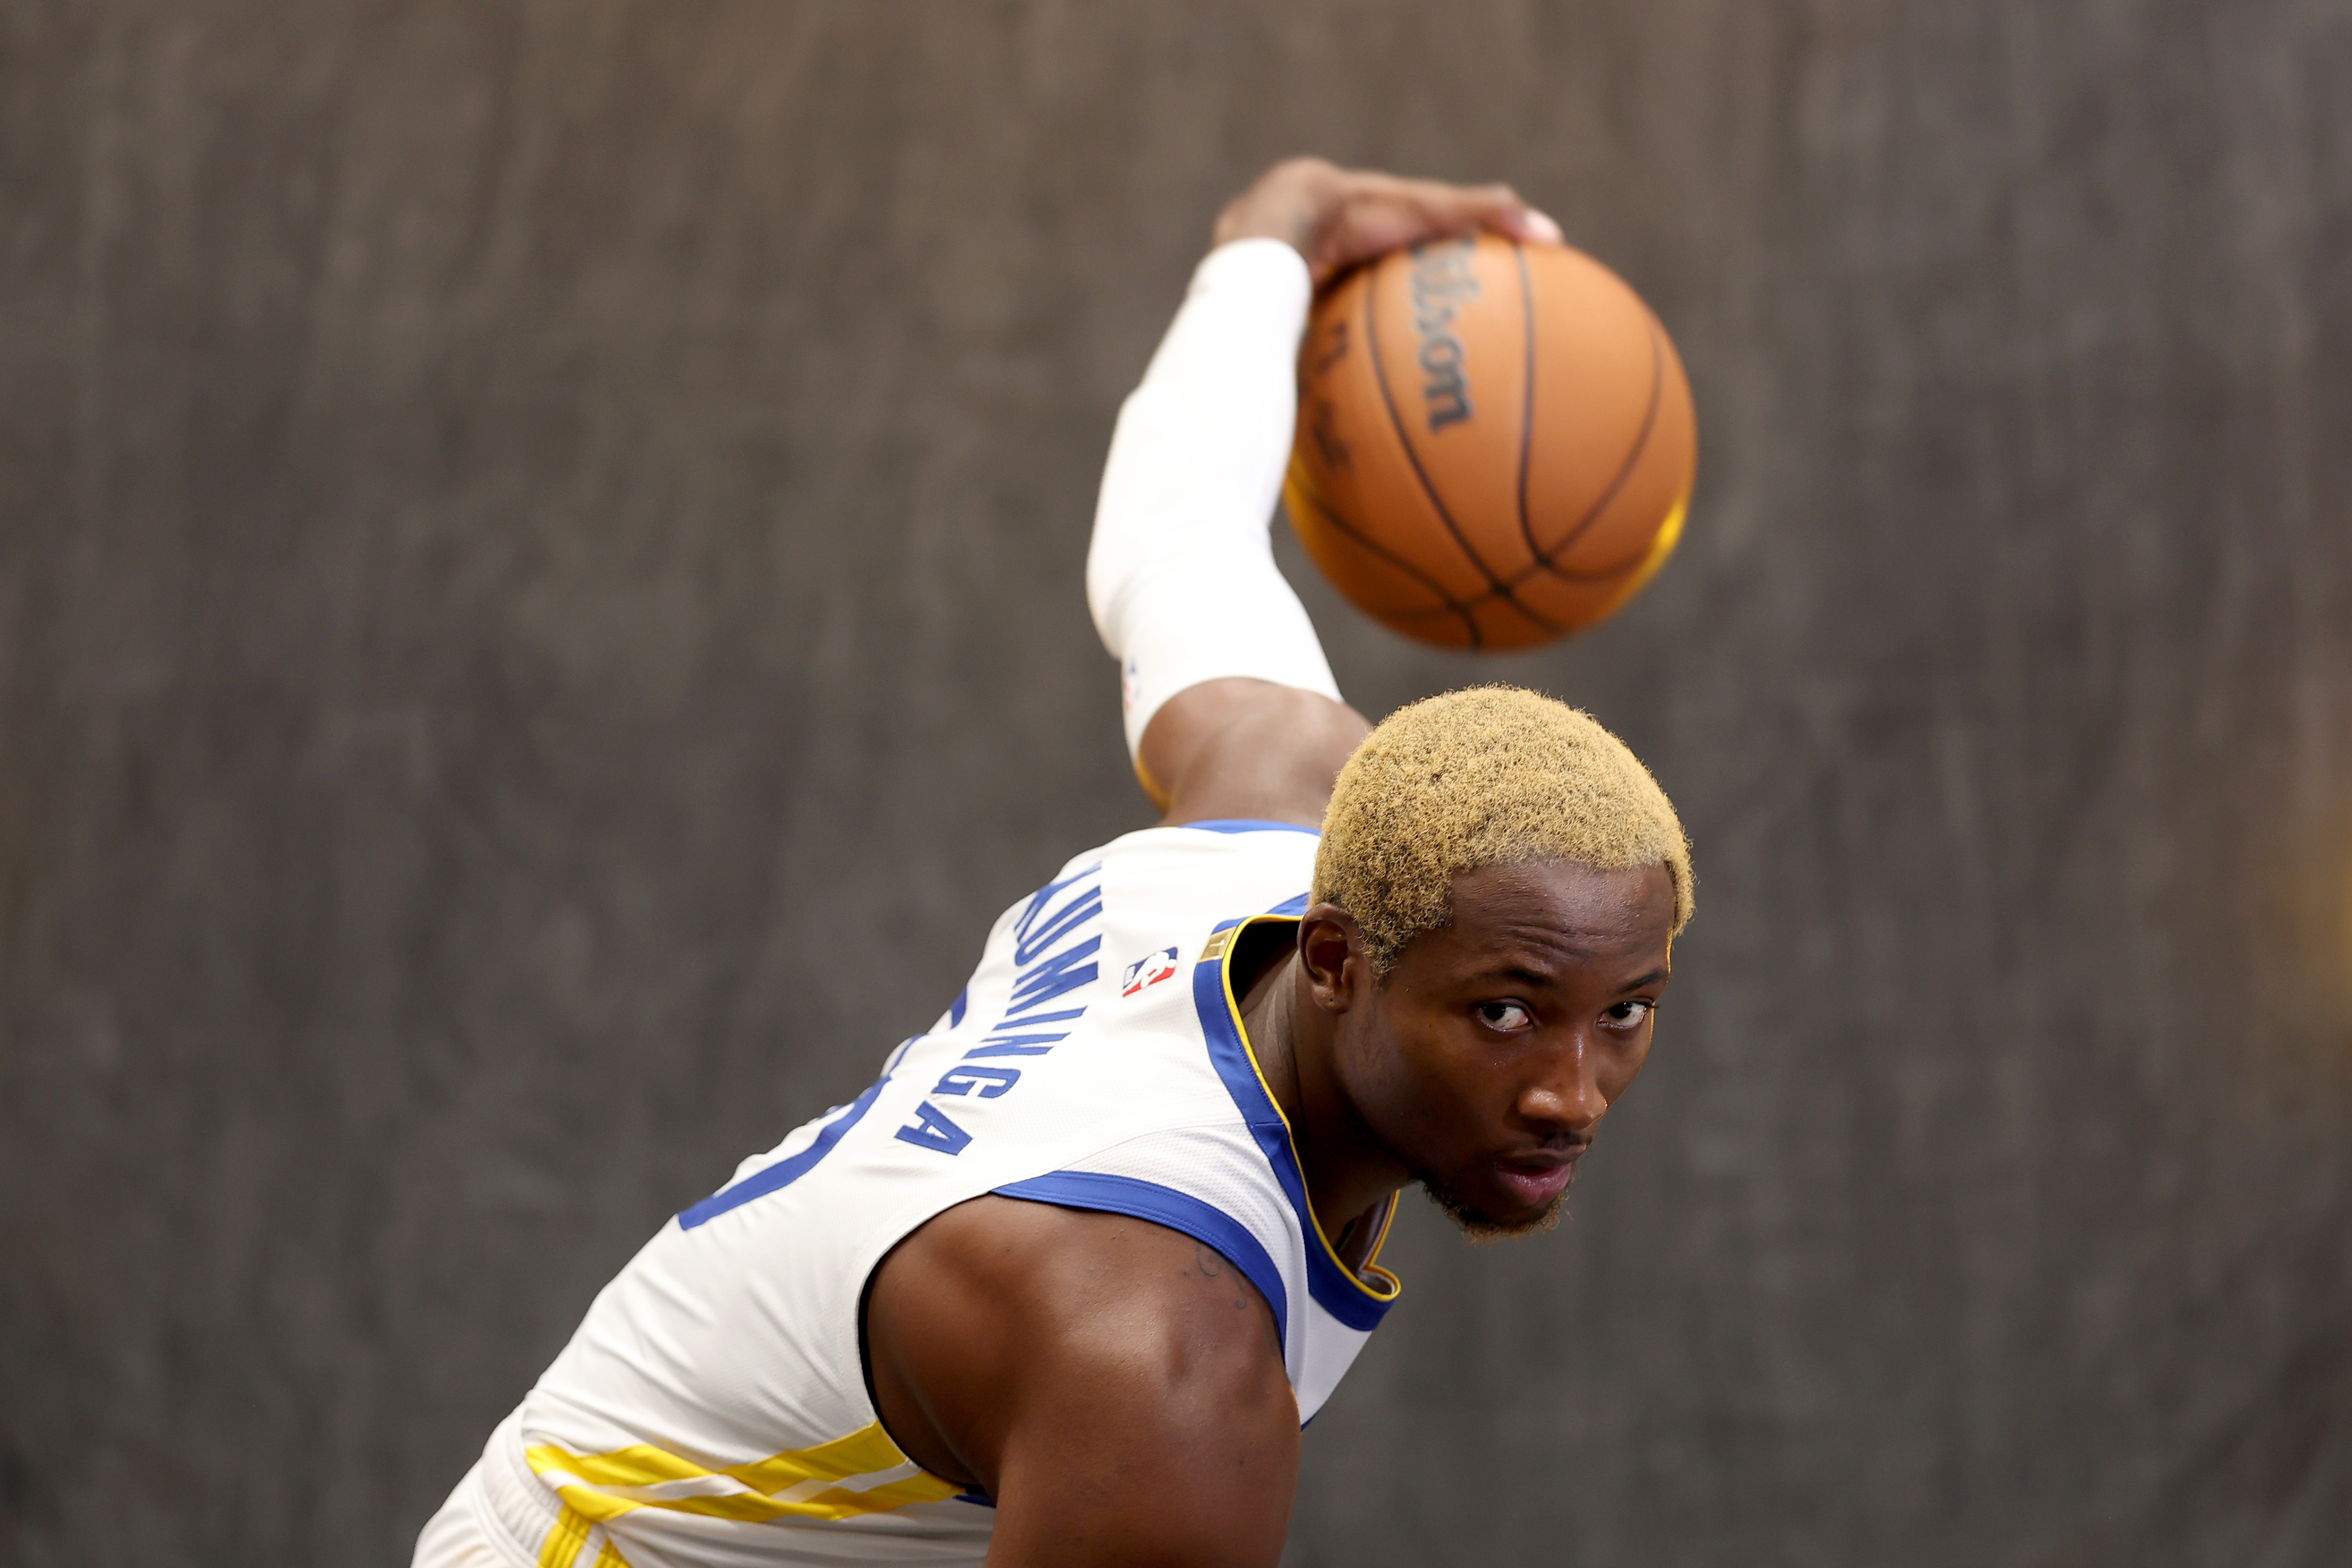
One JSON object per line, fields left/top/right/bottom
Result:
{"left": 416, "top": 162, "right": 1691, "bottom": 1568}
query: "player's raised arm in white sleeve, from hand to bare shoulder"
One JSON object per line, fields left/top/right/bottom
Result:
{"left": 1087, "top": 158, "right": 1559, "bottom": 825}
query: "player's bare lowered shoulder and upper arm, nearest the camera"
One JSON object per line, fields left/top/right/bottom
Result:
{"left": 866, "top": 1197, "right": 1298, "bottom": 1568}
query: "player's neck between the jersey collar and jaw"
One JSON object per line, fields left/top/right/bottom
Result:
{"left": 1242, "top": 952, "right": 1411, "bottom": 1244}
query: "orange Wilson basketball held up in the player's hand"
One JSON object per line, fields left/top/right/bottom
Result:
{"left": 1282, "top": 235, "right": 1698, "bottom": 651}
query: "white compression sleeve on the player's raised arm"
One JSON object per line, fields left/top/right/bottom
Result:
{"left": 1087, "top": 240, "right": 1338, "bottom": 757}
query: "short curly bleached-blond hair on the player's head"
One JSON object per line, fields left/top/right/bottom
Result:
{"left": 1315, "top": 686, "right": 1693, "bottom": 976}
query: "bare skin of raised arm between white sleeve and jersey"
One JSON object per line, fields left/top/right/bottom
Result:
{"left": 1138, "top": 677, "right": 1371, "bottom": 828}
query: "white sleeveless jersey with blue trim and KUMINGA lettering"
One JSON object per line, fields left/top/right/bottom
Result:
{"left": 419, "top": 823, "right": 1397, "bottom": 1568}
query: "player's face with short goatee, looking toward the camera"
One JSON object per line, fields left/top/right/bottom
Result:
{"left": 1336, "top": 861, "right": 1675, "bottom": 1234}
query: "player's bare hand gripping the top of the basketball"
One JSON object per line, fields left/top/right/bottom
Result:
{"left": 1216, "top": 158, "right": 1559, "bottom": 287}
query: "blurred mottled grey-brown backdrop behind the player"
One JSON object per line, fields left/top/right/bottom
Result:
{"left": 0, "top": 0, "right": 2352, "bottom": 1568}
